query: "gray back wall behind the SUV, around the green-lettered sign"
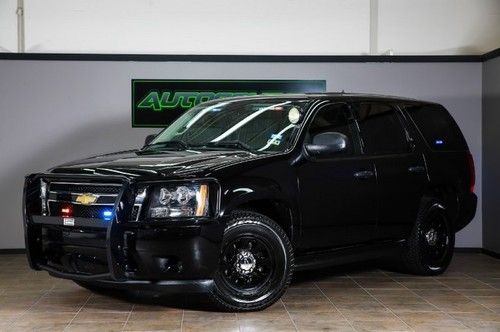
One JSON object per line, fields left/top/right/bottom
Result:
{"left": 0, "top": 61, "right": 482, "bottom": 248}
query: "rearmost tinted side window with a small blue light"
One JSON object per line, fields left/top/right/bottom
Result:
{"left": 405, "top": 105, "right": 467, "bottom": 150}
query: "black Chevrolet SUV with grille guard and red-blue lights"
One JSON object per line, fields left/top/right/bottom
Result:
{"left": 24, "top": 93, "right": 477, "bottom": 310}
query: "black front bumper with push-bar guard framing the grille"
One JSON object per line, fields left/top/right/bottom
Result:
{"left": 24, "top": 174, "right": 224, "bottom": 292}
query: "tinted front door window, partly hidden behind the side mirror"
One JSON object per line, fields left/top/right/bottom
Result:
{"left": 305, "top": 103, "right": 358, "bottom": 154}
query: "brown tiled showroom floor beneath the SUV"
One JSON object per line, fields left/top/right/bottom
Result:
{"left": 0, "top": 253, "right": 500, "bottom": 332}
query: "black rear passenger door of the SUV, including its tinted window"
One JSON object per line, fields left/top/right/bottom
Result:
{"left": 355, "top": 101, "right": 428, "bottom": 240}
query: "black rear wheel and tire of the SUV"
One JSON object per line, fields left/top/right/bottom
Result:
{"left": 403, "top": 198, "right": 455, "bottom": 276}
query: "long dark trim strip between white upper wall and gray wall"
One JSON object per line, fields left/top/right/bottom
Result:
{"left": 0, "top": 52, "right": 500, "bottom": 63}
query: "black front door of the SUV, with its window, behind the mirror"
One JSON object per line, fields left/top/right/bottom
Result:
{"left": 297, "top": 103, "right": 377, "bottom": 249}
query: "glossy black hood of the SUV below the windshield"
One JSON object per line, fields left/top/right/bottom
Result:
{"left": 49, "top": 150, "right": 257, "bottom": 178}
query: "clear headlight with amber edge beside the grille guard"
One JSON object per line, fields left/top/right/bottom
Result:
{"left": 147, "top": 183, "right": 209, "bottom": 218}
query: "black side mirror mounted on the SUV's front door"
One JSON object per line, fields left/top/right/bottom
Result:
{"left": 305, "top": 131, "right": 349, "bottom": 158}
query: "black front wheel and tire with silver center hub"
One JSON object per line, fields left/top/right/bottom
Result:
{"left": 211, "top": 211, "right": 294, "bottom": 311}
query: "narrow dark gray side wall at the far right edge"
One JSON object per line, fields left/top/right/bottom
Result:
{"left": 483, "top": 57, "right": 500, "bottom": 254}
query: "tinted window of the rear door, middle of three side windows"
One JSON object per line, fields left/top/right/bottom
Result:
{"left": 357, "top": 102, "right": 409, "bottom": 154}
